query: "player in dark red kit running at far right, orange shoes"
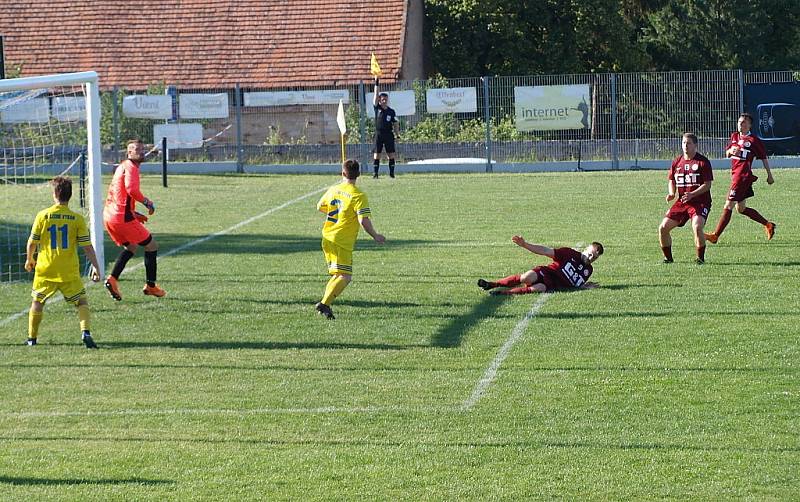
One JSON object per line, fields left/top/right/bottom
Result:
{"left": 706, "top": 113, "right": 775, "bottom": 244}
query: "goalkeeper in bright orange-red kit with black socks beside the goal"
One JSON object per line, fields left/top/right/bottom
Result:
{"left": 103, "top": 139, "right": 167, "bottom": 301}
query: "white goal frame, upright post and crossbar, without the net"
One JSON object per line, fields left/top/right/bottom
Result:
{"left": 0, "top": 71, "right": 105, "bottom": 277}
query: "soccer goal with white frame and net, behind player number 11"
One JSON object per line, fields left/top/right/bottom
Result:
{"left": 0, "top": 72, "right": 105, "bottom": 283}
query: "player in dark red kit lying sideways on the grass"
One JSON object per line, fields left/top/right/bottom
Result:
{"left": 478, "top": 235, "right": 603, "bottom": 295}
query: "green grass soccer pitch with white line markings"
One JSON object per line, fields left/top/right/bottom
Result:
{"left": 0, "top": 170, "right": 800, "bottom": 500}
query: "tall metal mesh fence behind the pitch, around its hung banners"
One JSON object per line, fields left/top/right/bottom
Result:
{"left": 102, "top": 70, "right": 799, "bottom": 168}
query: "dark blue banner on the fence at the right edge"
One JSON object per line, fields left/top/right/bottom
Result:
{"left": 744, "top": 82, "right": 800, "bottom": 155}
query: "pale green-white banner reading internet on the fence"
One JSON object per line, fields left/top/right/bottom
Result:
{"left": 514, "top": 84, "right": 591, "bottom": 131}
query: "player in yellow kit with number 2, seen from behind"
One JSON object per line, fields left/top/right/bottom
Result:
{"left": 315, "top": 159, "right": 386, "bottom": 319}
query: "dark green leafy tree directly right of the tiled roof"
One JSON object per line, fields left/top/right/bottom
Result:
{"left": 426, "top": 0, "right": 646, "bottom": 77}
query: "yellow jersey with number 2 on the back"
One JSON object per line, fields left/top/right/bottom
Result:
{"left": 317, "top": 181, "right": 372, "bottom": 250}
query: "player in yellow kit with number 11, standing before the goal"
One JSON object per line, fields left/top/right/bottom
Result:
{"left": 25, "top": 176, "right": 100, "bottom": 349}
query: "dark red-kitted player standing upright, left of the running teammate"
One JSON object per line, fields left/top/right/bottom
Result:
{"left": 658, "top": 132, "right": 714, "bottom": 264}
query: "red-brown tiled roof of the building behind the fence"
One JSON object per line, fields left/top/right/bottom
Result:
{"left": 0, "top": 0, "right": 408, "bottom": 90}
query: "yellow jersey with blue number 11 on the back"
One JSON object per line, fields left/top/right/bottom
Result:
{"left": 30, "top": 204, "right": 91, "bottom": 282}
